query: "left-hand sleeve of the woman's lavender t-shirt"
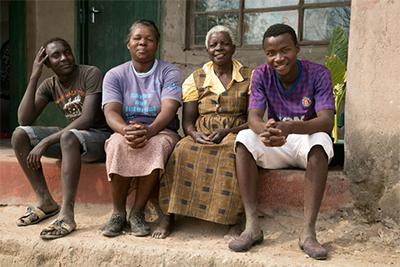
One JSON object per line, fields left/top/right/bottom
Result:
{"left": 101, "top": 70, "right": 123, "bottom": 108}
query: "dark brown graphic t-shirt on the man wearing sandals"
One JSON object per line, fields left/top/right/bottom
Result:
{"left": 36, "top": 65, "right": 107, "bottom": 128}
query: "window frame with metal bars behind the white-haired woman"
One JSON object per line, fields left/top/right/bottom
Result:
{"left": 185, "top": 0, "right": 351, "bottom": 50}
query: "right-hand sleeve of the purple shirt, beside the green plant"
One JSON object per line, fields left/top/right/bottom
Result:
{"left": 314, "top": 67, "right": 335, "bottom": 112}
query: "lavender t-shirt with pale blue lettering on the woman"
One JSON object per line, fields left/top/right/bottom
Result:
{"left": 102, "top": 60, "right": 182, "bottom": 128}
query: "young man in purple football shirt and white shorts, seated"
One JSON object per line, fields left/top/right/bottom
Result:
{"left": 229, "top": 24, "right": 335, "bottom": 259}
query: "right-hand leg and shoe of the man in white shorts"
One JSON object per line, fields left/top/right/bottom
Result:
{"left": 299, "top": 146, "right": 328, "bottom": 259}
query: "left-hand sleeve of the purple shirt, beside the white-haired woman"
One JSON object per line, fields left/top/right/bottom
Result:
{"left": 249, "top": 69, "right": 267, "bottom": 111}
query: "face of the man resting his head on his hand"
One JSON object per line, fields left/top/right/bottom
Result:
{"left": 46, "top": 41, "right": 76, "bottom": 76}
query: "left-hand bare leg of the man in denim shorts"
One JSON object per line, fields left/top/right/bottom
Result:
{"left": 11, "top": 129, "right": 58, "bottom": 213}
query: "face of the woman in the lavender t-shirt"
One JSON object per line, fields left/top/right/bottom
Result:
{"left": 127, "top": 25, "right": 158, "bottom": 63}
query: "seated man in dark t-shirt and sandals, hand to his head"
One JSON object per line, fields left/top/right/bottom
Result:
{"left": 11, "top": 38, "right": 110, "bottom": 239}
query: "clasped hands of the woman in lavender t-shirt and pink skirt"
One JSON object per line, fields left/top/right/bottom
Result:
{"left": 122, "top": 121, "right": 154, "bottom": 148}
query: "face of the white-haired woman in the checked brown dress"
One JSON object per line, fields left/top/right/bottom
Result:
{"left": 207, "top": 32, "right": 235, "bottom": 65}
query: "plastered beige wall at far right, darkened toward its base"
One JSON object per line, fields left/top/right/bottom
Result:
{"left": 345, "top": 0, "right": 400, "bottom": 226}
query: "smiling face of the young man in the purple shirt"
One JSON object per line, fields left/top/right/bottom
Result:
{"left": 263, "top": 33, "right": 300, "bottom": 80}
